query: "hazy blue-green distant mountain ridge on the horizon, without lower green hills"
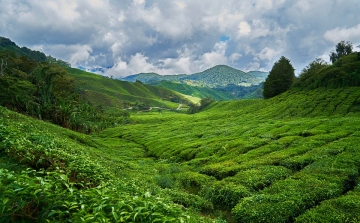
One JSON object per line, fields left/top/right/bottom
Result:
{"left": 122, "top": 65, "right": 268, "bottom": 88}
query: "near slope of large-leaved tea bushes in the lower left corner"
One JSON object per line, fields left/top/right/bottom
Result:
{"left": 0, "top": 107, "right": 197, "bottom": 223}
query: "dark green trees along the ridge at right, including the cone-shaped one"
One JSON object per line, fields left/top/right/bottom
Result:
{"left": 263, "top": 41, "right": 360, "bottom": 98}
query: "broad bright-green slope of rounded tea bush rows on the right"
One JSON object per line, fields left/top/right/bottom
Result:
{"left": 101, "top": 87, "right": 360, "bottom": 222}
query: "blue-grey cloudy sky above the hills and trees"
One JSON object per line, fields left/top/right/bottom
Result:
{"left": 0, "top": 0, "right": 360, "bottom": 77}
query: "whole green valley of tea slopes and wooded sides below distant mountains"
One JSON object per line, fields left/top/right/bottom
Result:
{"left": 0, "top": 35, "right": 360, "bottom": 223}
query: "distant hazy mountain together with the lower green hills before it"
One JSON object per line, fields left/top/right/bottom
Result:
{"left": 122, "top": 65, "right": 268, "bottom": 100}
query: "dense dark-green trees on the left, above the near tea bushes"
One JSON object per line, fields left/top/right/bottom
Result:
{"left": 0, "top": 50, "right": 128, "bottom": 133}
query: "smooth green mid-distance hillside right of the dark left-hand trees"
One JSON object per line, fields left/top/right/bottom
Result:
{"left": 67, "top": 68, "right": 187, "bottom": 108}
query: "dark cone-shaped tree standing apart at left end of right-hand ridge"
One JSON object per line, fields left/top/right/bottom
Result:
{"left": 263, "top": 56, "right": 295, "bottom": 98}
